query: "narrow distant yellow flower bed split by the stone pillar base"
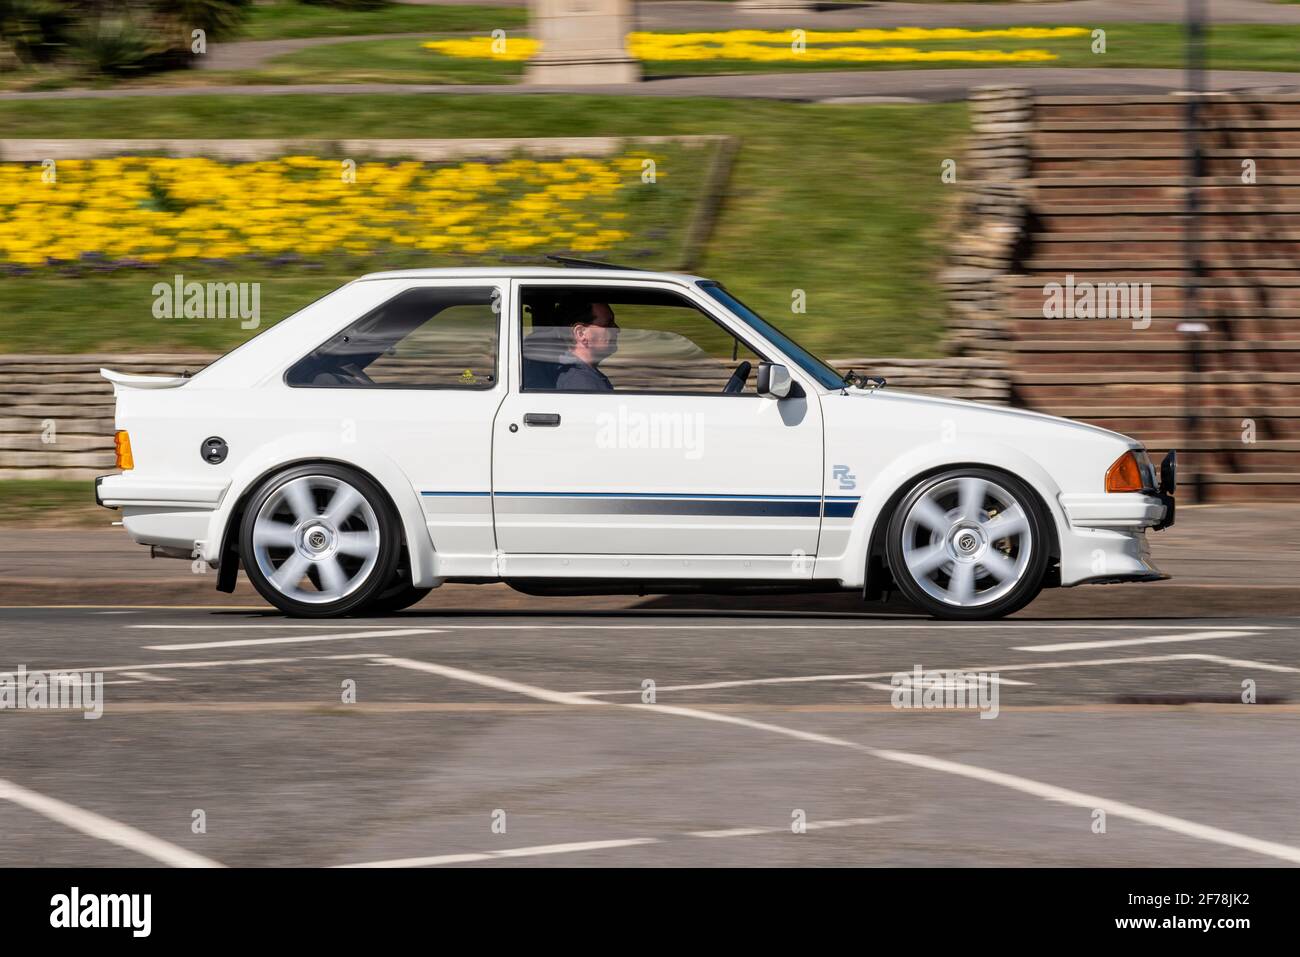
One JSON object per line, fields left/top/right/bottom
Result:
{"left": 423, "top": 26, "right": 1088, "bottom": 62}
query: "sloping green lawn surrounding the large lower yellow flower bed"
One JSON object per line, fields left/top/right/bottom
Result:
{"left": 0, "top": 95, "right": 966, "bottom": 356}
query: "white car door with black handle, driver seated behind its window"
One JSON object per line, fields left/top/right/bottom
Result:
{"left": 493, "top": 280, "right": 822, "bottom": 577}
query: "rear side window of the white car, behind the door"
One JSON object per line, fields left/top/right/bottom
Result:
{"left": 285, "top": 286, "right": 501, "bottom": 389}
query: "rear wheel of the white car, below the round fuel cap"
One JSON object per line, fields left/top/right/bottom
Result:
{"left": 239, "top": 463, "right": 402, "bottom": 618}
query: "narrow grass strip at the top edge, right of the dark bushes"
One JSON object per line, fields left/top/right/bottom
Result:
{"left": 237, "top": 0, "right": 528, "bottom": 40}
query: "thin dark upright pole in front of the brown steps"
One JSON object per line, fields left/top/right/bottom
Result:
{"left": 1183, "top": 0, "right": 1205, "bottom": 502}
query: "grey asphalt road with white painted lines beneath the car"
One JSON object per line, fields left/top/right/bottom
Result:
{"left": 0, "top": 607, "right": 1300, "bottom": 866}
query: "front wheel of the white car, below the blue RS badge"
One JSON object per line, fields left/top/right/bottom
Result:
{"left": 887, "top": 468, "right": 1049, "bottom": 619}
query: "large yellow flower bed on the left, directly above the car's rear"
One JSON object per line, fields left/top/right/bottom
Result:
{"left": 0, "top": 155, "right": 664, "bottom": 265}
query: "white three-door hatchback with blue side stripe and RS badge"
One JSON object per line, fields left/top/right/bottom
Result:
{"left": 96, "top": 261, "right": 1174, "bottom": 619}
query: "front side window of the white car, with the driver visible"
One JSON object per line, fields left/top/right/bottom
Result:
{"left": 520, "top": 286, "right": 762, "bottom": 395}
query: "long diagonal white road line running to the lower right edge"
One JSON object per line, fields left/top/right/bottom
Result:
{"left": 386, "top": 658, "right": 1300, "bottom": 863}
